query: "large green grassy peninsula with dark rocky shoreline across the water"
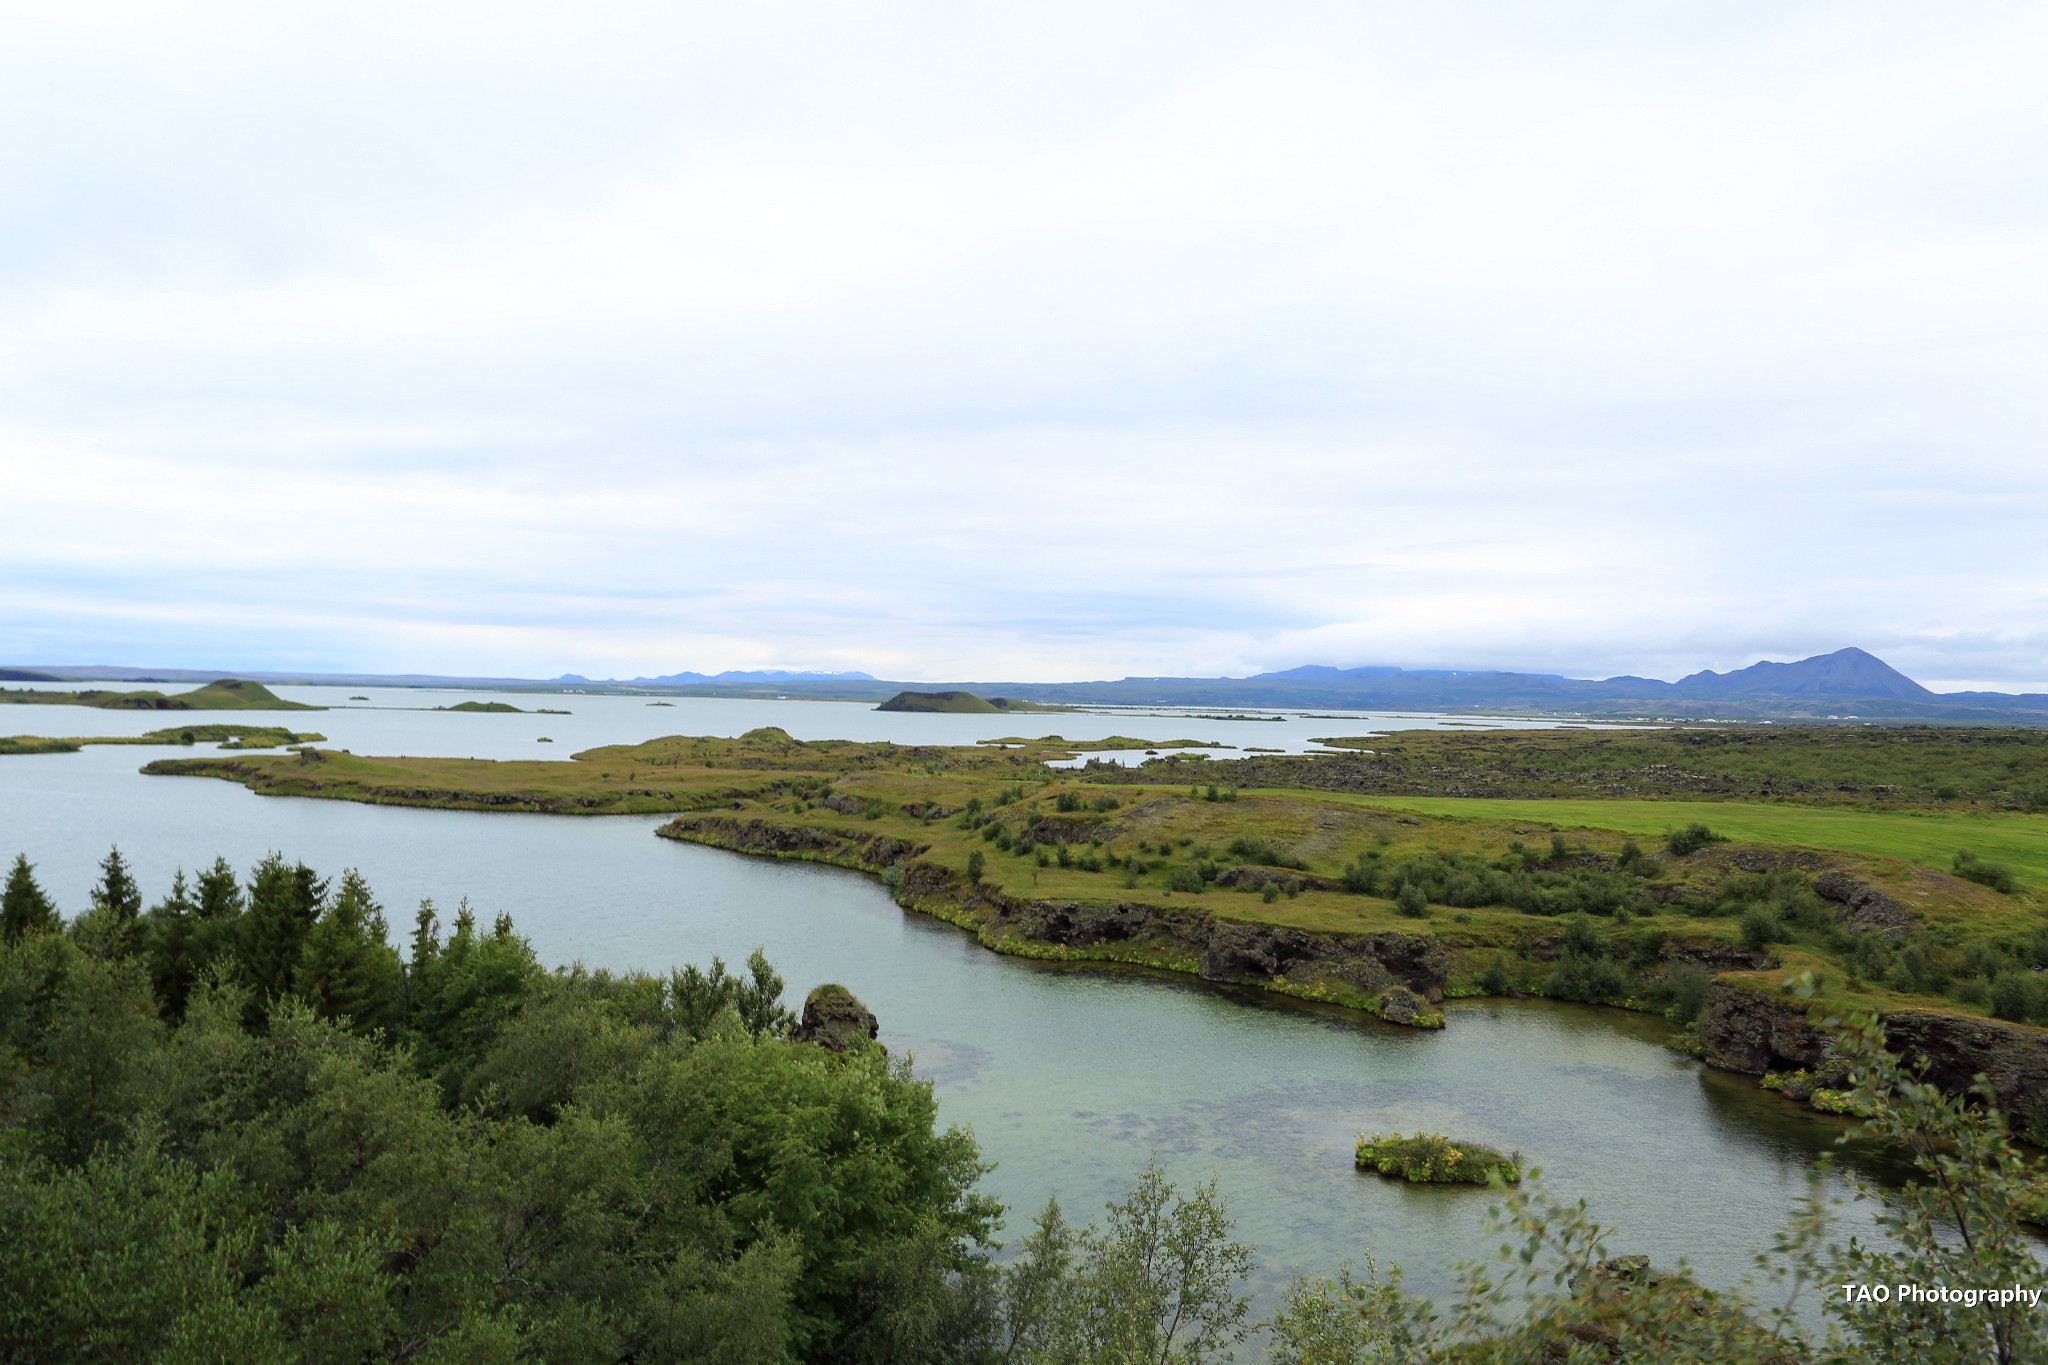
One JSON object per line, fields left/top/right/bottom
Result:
{"left": 145, "top": 726, "right": 2048, "bottom": 1138}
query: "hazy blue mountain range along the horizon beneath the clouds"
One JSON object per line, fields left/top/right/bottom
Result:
{"left": 8, "top": 649, "right": 2048, "bottom": 724}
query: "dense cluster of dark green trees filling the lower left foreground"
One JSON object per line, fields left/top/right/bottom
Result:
{"left": 0, "top": 853, "right": 997, "bottom": 1361}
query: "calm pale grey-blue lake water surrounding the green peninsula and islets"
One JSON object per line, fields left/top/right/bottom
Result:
{"left": 0, "top": 688, "right": 1868, "bottom": 1295}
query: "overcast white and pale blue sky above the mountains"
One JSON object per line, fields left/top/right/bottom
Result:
{"left": 0, "top": 0, "right": 2048, "bottom": 692}
